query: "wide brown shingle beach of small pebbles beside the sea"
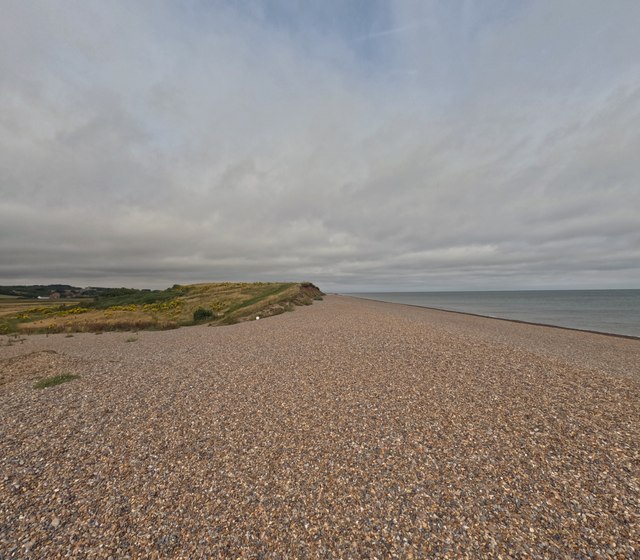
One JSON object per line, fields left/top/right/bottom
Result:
{"left": 0, "top": 296, "right": 640, "bottom": 559}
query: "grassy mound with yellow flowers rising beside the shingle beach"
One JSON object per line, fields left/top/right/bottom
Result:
{"left": 0, "top": 282, "right": 323, "bottom": 334}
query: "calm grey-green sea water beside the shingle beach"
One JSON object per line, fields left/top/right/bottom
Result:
{"left": 349, "top": 290, "right": 640, "bottom": 337}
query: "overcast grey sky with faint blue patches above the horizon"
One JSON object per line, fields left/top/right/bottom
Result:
{"left": 0, "top": 0, "right": 640, "bottom": 291}
